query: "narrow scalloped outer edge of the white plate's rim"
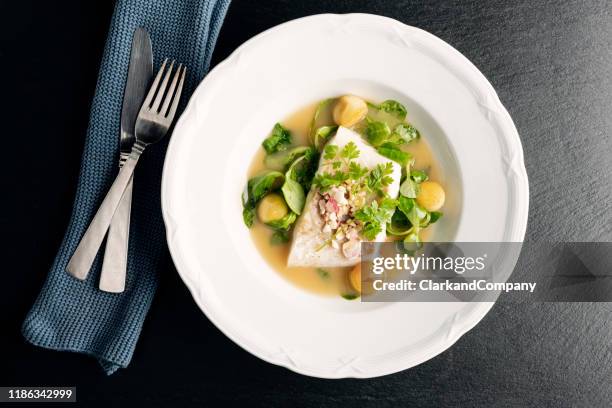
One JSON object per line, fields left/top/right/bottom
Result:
{"left": 161, "top": 13, "right": 529, "bottom": 379}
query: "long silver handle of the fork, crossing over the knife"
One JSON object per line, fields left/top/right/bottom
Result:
{"left": 66, "top": 142, "right": 145, "bottom": 280}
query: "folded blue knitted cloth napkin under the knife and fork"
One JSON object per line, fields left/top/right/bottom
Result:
{"left": 22, "top": 0, "right": 230, "bottom": 374}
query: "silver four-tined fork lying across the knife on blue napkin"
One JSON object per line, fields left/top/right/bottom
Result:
{"left": 66, "top": 59, "right": 186, "bottom": 280}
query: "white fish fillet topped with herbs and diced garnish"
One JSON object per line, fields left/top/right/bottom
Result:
{"left": 287, "top": 127, "right": 402, "bottom": 268}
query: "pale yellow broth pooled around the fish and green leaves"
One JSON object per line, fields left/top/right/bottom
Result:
{"left": 247, "top": 99, "right": 442, "bottom": 296}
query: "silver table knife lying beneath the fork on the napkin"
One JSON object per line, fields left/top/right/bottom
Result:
{"left": 99, "top": 27, "right": 153, "bottom": 293}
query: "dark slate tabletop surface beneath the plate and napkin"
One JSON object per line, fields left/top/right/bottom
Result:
{"left": 0, "top": 0, "right": 612, "bottom": 407}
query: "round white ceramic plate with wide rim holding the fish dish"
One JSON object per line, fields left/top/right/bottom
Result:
{"left": 162, "top": 14, "right": 529, "bottom": 378}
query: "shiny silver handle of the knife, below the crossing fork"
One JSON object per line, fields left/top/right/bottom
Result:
{"left": 99, "top": 177, "right": 134, "bottom": 293}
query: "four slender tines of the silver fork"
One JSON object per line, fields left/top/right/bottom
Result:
{"left": 141, "top": 58, "right": 186, "bottom": 121}
